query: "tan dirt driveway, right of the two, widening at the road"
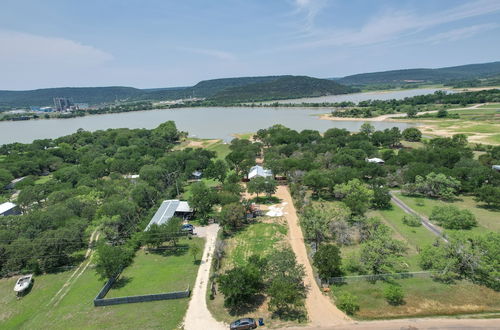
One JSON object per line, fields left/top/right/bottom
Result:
{"left": 276, "top": 186, "right": 349, "bottom": 327}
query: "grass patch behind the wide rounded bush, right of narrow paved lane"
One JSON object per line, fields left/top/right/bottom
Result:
{"left": 396, "top": 193, "right": 500, "bottom": 232}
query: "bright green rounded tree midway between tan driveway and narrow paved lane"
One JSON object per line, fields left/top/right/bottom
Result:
{"left": 334, "top": 179, "right": 373, "bottom": 215}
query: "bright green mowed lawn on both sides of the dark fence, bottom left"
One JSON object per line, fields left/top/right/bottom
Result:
{"left": 0, "top": 239, "right": 201, "bottom": 329}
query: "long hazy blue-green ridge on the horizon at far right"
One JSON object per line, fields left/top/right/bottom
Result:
{"left": 334, "top": 62, "right": 500, "bottom": 85}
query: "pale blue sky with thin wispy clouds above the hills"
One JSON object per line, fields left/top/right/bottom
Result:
{"left": 0, "top": 0, "right": 500, "bottom": 90}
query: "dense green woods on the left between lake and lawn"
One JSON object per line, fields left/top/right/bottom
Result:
{"left": 0, "top": 122, "right": 223, "bottom": 275}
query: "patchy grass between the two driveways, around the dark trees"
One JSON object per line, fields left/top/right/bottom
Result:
{"left": 207, "top": 218, "right": 297, "bottom": 328}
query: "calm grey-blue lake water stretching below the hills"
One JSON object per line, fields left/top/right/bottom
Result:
{"left": 0, "top": 89, "right": 436, "bottom": 144}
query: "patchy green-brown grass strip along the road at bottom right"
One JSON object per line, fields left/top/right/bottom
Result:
{"left": 331, "top": 278, "right": 500, "bottom": 319}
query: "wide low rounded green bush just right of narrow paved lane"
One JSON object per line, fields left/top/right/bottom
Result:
{"left": 429, "top": 205, "right": 477, "bottom": 229}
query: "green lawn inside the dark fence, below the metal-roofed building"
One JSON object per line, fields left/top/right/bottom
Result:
{"left": 106, "top": 238, "right": 204, "bottom": 298}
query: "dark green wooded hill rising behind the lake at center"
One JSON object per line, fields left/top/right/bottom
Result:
{"left": 210, "top": 76, "right": 358, "bottom": 103}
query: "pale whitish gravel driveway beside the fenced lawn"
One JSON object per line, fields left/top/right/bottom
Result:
{"left": 184, "top": 224, "right": 229, "bottom": 330}
